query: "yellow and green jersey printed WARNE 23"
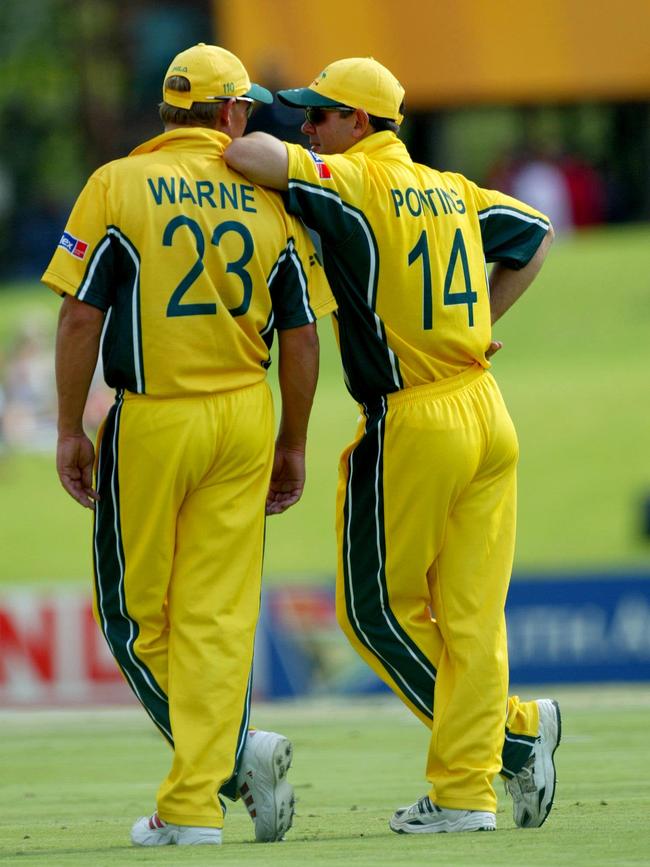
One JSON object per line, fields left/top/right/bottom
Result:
{"left": 42, "top": 127, "right": 335, "bottom": 396}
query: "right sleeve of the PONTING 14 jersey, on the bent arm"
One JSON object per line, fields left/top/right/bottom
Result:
{"left": 470, "top": 184, "right": 550, "bottom": 271}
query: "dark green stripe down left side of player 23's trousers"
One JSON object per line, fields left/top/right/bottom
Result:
{"left": 94, "top": 397, "right": 173, "bottom": 745}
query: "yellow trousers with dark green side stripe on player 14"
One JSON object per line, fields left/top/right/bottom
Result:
{"left": 337, "top": 366, "right": 539, "bottom": 812}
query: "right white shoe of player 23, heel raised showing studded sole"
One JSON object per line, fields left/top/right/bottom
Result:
{"left": 237, "top": 730, "right": 295, "bottom": 843}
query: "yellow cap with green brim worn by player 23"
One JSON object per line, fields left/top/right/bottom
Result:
{"left": 163, "top": 42, "right": 273, "bottom": 108}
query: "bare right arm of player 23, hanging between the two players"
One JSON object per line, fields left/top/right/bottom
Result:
{"left": 266, "top": 323, "right": 319, "bottom": 515}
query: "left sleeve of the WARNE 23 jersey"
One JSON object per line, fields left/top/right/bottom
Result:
{"left": 41, "top": 173, "right": 115, "bottom": 311}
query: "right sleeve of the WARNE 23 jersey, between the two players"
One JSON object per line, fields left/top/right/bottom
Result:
{"left": 269, "top": 215, "right": 336, "bottom": 331}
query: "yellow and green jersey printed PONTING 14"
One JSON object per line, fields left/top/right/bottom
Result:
{"left": 286, "top": 132, "right": 549, "bottom": 403}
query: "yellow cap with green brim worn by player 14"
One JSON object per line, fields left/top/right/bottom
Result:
{"left": 278, "top": 57, "right": 404, "bottom": 123}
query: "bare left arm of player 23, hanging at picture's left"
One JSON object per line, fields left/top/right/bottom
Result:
{"left": 56, "top": 295, "right": 104, "bottom": 509}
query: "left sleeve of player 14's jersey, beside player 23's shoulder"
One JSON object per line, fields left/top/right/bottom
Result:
{"left": 285, "top": 142, "right": 368, "bottom": 243}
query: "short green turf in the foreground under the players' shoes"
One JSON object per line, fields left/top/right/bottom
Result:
{"left": 0, "top": 686, "right": 650, "bottom": 867}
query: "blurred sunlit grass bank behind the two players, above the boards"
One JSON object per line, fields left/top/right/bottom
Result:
{"left": 0, "top": 226, "right": 650, "bottom": 584}
